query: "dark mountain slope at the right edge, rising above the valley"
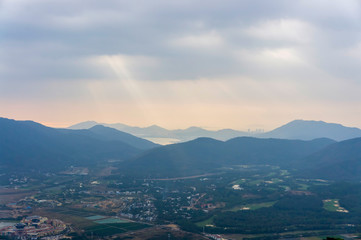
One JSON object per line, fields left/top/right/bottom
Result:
{"left": 295, "top": 138, "right": 361, "bottom": 181}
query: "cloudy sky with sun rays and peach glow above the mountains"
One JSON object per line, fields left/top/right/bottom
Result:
{"left": 0, "top": 0, "right": 361, "bottom": 131}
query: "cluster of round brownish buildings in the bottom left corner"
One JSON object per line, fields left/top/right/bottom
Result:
{"left": 0, "top": 216, "right": 67, "bottom": 239}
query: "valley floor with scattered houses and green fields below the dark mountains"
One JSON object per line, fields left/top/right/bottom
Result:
{"left": 0, "top": 165, "right": 361, "bottom": 239}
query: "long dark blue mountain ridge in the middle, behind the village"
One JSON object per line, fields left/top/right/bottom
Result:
{"left": 120, "top": 137, "right": 334, "bottom": 177}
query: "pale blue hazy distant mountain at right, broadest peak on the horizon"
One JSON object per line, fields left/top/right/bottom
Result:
{"left": 259, "top": 120, "right": 361, "bottom": 141}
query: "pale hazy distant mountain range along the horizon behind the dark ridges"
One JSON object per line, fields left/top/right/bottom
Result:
{"left": 69, "top": 120, "right": 361, "bottom": 144}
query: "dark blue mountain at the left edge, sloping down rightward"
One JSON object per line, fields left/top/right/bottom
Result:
{"left": 0, "top": 118, "right": 148, "bottom": 170}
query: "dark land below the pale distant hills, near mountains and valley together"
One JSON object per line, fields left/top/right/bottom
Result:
{"left": 0, "top": 119, "right": 361, "bottom": 240}
